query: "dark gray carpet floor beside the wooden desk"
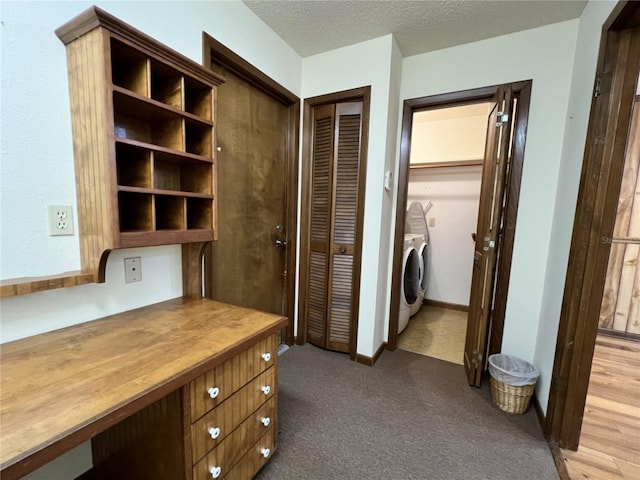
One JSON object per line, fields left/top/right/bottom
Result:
{"left": 255, "top": 345, "right": 558, "bottom": 480}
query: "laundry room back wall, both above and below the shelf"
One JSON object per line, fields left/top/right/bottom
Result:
{"left": 407, "top": 107, "right": 493, "bottom": 306}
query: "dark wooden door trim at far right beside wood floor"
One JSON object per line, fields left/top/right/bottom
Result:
{"left": 544, "top": 2, "right": 640, "bottom": 450}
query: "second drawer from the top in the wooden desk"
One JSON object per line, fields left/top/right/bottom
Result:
{"left": 191, "top": 368, "right": 276, "bottom": 464}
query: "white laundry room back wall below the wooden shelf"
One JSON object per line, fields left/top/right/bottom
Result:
{"left": 407, "top": 167, "right": 486, "bottom": 306}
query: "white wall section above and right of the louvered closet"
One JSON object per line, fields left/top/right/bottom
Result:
{"left": 302, "top": 35, "right": 399, "bottom": 357}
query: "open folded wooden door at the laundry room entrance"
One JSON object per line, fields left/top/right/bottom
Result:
{"left": 464, "top": 85, "right": 513, "bottom": 387}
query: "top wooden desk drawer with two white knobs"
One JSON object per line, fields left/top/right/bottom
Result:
{"left": 189, "top": 335, "right": 278, "bottom": 421}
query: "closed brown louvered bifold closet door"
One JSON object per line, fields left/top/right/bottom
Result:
{"left": 307, "top": 102, "right": 362, "bottom": 352}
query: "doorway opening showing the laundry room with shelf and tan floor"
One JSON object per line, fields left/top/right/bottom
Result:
{"left": 398, "top": 101, "right": 492, "bottom": 364}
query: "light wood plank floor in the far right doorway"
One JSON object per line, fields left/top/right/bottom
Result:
{"left": 562, "top": 335, "right": 640, "bottom": 480}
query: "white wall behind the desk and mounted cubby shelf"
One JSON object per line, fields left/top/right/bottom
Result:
{"left": 0, "top": 0, "right": 301, "bottom": 480}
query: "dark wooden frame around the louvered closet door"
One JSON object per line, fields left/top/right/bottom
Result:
{"left": 296, "top": 86, "right": 371, "bottom": 361}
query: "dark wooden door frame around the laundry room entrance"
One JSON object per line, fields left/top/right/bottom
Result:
{"left": 386, "top": 80, "right": 533, "bottom": 354}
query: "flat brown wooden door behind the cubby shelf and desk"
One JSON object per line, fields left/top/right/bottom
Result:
{"left": 205, "top": 56, "right": 291, "bottom": 315}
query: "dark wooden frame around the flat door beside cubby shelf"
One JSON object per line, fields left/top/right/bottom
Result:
{"left": 202, "top": 32, "right": 300, "bottom": 345}
